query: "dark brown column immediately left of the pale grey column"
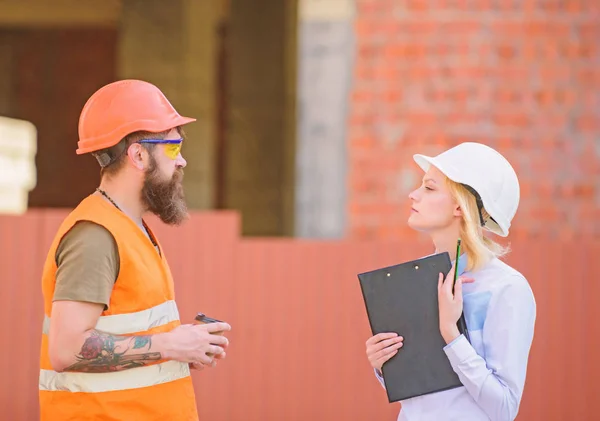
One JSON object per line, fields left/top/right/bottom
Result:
{"left": 224, "top": 0, "right": 297, "bottom": 236}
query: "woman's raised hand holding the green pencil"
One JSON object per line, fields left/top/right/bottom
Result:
{"left": 438, "top": 266, "right": 475, "bottom": 344}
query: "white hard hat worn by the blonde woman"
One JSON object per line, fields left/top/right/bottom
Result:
{"left": 413, "top": 142, "right": 520, "bottom": 237}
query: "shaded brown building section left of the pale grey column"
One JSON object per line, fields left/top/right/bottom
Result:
{"left": 0, "top": 0, "right": 297, "bottom": 236}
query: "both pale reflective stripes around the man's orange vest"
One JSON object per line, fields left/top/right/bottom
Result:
{"left": 39, "top": 300, "right": 190, "bottom": 393}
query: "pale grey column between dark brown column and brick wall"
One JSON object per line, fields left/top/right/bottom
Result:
{"left": 295, "top": 0, "right": 355, "bottom": 238}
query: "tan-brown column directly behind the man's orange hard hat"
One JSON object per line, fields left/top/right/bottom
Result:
{"left": 118, "top": 0, "right": 222, "bottom": 209}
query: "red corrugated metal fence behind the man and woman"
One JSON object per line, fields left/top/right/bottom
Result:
{"left": 0, "top": 210, "right": 600, "bottom": 421}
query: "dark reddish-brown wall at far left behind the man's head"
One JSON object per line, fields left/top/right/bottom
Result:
{"left": 0, "top": 27, "right": 117, "bottom": 207}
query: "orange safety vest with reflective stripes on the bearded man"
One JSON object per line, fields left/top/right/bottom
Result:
{"left": 39, "top": 195, "right": 198, "bottom": 421}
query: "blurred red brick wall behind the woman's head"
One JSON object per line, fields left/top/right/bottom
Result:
{"left": 348, "top": 0, "right": 600, "bottom": 238}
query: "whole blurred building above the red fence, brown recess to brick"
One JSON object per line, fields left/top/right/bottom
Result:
{"left": 0, "top": 0, "right": 600, "bottom": 239}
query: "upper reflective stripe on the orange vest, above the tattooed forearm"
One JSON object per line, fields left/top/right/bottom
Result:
{"left": 42, "top": 300, "right": 179, "bottom": 335}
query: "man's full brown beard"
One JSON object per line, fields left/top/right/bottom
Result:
{"left": 142, "top": 157, "right": 188, "bottom": 225}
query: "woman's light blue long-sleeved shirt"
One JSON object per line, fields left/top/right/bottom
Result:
{"left": 375, "top": 255, "right": 536, "bottom": 421}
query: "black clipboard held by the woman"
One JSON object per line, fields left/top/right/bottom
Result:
{"left": 358, "top": 253, "right": 469, "bottom": 403}
